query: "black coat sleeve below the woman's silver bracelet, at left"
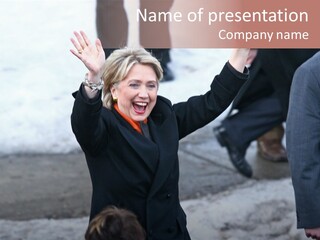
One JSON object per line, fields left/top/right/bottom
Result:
{"left": 71, "top": 86, "right": 108, "bottom": 155}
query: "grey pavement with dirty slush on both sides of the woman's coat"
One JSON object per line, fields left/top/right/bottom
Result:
{"left": 0, "top": 120, "right": 306, "bottom": 240}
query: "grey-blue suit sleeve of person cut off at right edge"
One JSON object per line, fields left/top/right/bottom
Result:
{"left": 286, "top": 54, "right": 320, "bottom": 228}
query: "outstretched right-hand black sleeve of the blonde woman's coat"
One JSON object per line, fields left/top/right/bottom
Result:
{"left": 173, "top": 62, "right": 249, "bottom": 139}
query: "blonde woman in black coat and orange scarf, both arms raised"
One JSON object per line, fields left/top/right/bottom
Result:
{"left": 71, "top": 32, "right": 249, "bottom": 240}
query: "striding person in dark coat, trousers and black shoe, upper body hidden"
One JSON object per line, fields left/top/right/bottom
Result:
{"left": 213, "top": 49, "right": 318, "bottom": 177}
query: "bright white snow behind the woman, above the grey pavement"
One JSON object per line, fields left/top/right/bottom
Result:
{"left": 0, "top": 0, "right": 230, "bottom": 156}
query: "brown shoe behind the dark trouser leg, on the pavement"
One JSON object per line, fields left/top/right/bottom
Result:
{"left": 257, "top": 125, "right": 288, "bottom": 162}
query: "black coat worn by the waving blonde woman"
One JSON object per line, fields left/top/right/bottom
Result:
{"left": 71, "top": 64, "right": 248, "bottom": 240}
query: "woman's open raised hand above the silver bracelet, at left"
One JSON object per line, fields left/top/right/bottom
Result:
{"left": 70, "top": 31, "right": 105, "bottom": 81}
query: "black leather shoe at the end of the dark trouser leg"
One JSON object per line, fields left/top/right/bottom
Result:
{"left": 213, "top": 126, "right": 252, "bottom": 178}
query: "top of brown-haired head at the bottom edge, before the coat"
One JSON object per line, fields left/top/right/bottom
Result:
{"left": 85, "top": 206, "right": 146, "bottom": 240}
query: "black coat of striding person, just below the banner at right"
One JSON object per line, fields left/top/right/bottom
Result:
{"left": 230, "top": 49, "right": 319, "bottom": 119}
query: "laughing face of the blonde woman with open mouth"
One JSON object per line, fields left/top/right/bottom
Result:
{"left": 111, "top": 64, "right": 158, "bottom": 121}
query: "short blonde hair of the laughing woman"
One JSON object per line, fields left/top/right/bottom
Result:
{"left": 102, "top": 48, "right": 163, "bottom": 109}
